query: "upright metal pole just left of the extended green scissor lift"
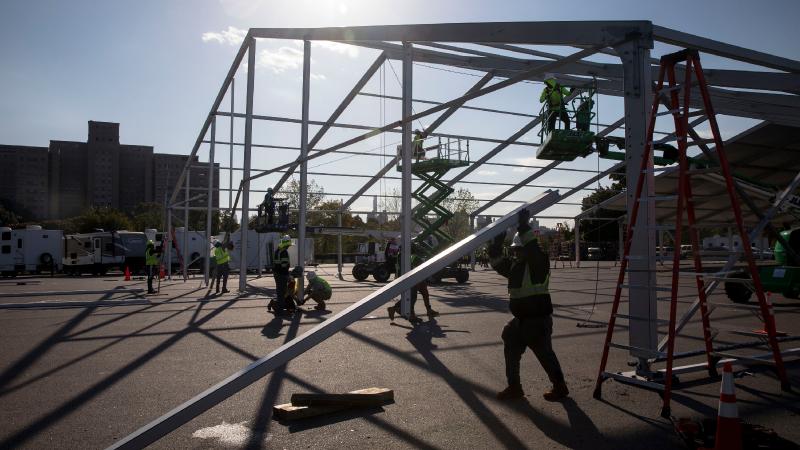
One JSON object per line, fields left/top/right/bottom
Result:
{"left": 398, "top": 42, "right": 414, "bottom": 319}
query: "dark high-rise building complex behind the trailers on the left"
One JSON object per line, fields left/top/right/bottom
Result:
{"left": 0, "top": 121, "right": 219, "bottom": 219}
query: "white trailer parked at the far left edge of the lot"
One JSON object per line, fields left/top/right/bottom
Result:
{"left": 0, "top": 225, "right": 63, "bottom": 276}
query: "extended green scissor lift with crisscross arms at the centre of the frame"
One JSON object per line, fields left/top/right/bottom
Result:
{"left": 397, "top": 138, "right": 469, "bottom": 283}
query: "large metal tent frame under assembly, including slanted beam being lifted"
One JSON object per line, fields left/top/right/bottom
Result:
{"left": 116, "top": 21, "right": 800, "bottom": 448}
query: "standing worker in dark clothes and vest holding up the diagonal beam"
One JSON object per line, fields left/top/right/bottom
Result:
{"left": 489, "top": 209, "right": 569, "bottom": 401}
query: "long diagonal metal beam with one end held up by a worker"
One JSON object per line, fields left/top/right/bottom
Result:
{"left": 104, "top": 191, "right": 559, "bottom": 449}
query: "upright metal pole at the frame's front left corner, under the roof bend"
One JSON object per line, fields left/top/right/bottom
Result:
{"left": 239, "top": 38, "right": 256, "bottom": 292}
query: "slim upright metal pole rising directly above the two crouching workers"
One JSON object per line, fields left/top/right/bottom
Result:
{"left": 297, "top": 41, "right": 311, "bottom": 293}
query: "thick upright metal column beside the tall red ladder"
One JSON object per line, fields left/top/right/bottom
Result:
{"left": 615, "top": 39, "right": 658, "bottom": 374}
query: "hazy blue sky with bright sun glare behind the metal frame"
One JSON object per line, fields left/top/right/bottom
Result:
{"left": 0, "top": 0, "right": 800, "bottom": 222}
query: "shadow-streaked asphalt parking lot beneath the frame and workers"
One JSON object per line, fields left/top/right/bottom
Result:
{"left": 0, "top": 263, "right": 800, "bottom": 450}
